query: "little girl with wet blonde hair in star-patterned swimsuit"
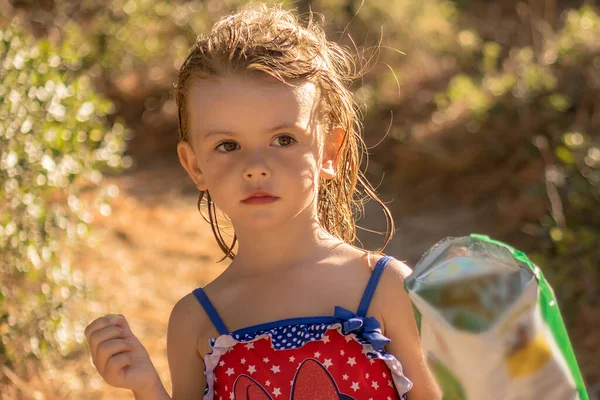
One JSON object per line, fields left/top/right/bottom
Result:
{"left": 86, "top": 6, "right": 440, "bottom": 400}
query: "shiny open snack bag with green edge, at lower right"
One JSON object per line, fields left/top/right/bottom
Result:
{"left": 406, "top": 234, "right": 589, "bottom": 400}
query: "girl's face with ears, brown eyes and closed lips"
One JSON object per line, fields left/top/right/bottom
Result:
{"left": 178, "top": 76, "right": 343, "bottom": 230}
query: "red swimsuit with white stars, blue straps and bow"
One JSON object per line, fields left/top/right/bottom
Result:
{"left": 194, "top": 257, "right": 412, "bottom": 400}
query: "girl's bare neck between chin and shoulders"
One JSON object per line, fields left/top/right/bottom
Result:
{"left": 229, "top": 218, "right": 343, "bottom": 273}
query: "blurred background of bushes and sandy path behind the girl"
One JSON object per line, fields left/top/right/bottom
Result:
{"left": 0, "top": 0, "right": 600, "bottom": 400}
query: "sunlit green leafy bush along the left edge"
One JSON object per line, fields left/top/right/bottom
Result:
{"left": 0, "top": 22, "right": 130, "bottom": 363}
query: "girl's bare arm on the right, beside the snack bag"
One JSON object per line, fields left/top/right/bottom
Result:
{"left": 373, "top": 260, "right": 442, "bottom": 400}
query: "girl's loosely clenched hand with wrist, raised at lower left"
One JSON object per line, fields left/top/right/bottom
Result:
{"left": 85, "top": 315, "right": 164, "bottom": 398}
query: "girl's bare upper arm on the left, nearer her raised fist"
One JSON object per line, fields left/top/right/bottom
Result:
{"left": 167, "top": 294, "right": 212, "bottom": 400}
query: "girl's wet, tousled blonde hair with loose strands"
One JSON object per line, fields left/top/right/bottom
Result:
{"left": 175, "top": 4, "right": 394, "bottom": 259}
